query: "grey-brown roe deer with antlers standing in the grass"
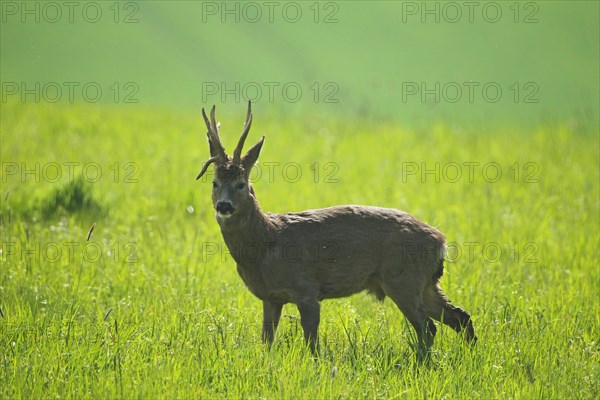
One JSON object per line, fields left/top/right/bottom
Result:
{"left": 196, "top": 102, "right": 477, "bottom": 354}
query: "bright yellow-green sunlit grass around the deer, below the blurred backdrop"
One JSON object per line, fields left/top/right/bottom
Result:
{"left": 0, "top": 102, "right": 600, "bottom": 399}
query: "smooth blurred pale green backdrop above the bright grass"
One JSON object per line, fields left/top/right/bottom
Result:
{"left": 1, "top": 1, "right": 600, "bottom": 130}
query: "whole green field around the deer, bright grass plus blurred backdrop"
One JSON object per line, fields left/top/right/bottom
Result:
{"left": 0, "top": 1, "right": 600, "bottom": 399}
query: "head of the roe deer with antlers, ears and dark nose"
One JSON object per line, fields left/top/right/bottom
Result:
{"left": 196, "top": 102, "right": 265, "bottom": 224}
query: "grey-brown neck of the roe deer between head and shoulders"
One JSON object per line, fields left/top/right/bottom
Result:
{"left": 221, "top": 200, "right": 273, "bottom": 266}
